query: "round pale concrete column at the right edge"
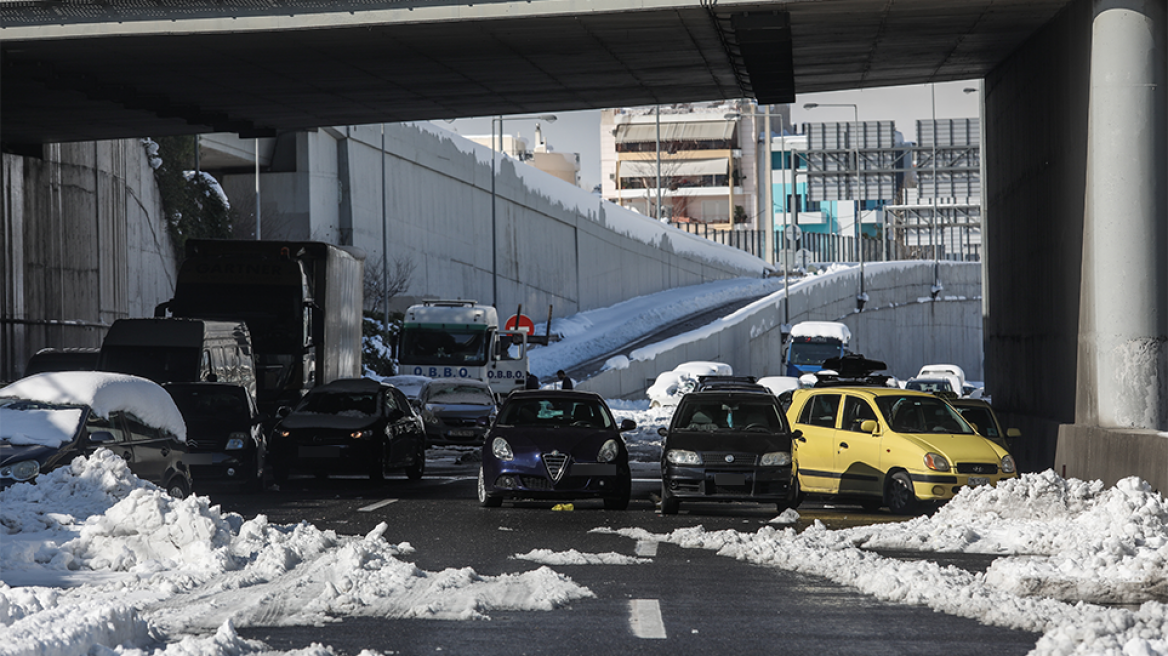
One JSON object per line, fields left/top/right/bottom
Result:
{"left": 1076, "top": 0, "right": 1168, "bottom": 430}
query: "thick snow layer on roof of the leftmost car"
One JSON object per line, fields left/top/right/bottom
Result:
{"left": 0, "top": 371, "right": 187, "bottom": 441}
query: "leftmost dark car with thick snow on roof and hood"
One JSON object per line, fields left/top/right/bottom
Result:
{"left": 0, "top": 371, "right": 190, "bottom": 498}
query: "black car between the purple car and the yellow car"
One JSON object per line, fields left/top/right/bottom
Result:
{"left": 659, "top": 391, "right": 793, "bottom": 515}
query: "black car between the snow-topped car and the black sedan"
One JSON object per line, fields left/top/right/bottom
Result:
{"left": 162, "top": 383, "right": 267, "bottom": 491}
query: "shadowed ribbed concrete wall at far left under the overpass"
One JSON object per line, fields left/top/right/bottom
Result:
{"left": 0, "top": 139, "right": 175, "bottom": 381}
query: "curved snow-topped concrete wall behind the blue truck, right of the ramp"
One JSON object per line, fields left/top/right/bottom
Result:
{"left": 578, "top": 261, "right": 982, "bottom": 399}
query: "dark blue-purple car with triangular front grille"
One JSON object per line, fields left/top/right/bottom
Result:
{"left": 479, "top": 390, "right": 637, "bottom": 510}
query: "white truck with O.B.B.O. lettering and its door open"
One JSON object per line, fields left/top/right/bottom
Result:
{"left": 397, "top": 300, "right": 529, "bottom": 398}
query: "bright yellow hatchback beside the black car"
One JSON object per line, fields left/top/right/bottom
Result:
{"left": 787, "top": 386, "right": 1017, "bottom": 515}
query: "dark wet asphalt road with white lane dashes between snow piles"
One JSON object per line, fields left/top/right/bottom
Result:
{"left": 209, "top": 451, "right": 1038, "bottom": 656}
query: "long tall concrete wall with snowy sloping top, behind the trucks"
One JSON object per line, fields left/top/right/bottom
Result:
{"left": 223, "top": 124, "right": 765, "bottom": 321}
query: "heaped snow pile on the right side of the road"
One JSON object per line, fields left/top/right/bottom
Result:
{"left": 595, "top": 470, "right": 1168, "bottom": 655}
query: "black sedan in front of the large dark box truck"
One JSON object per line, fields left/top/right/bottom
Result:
{"left": 269, "top": 378, "right": 426, "bottom": 481}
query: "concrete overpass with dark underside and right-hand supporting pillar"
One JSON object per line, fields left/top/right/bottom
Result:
{"left": 0, "top": 0, "right": 1168, "bottom": 487}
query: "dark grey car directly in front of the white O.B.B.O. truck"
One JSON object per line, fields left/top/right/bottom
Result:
{"left": 417, "top": 378, "right": 496, "bottom": 446}
